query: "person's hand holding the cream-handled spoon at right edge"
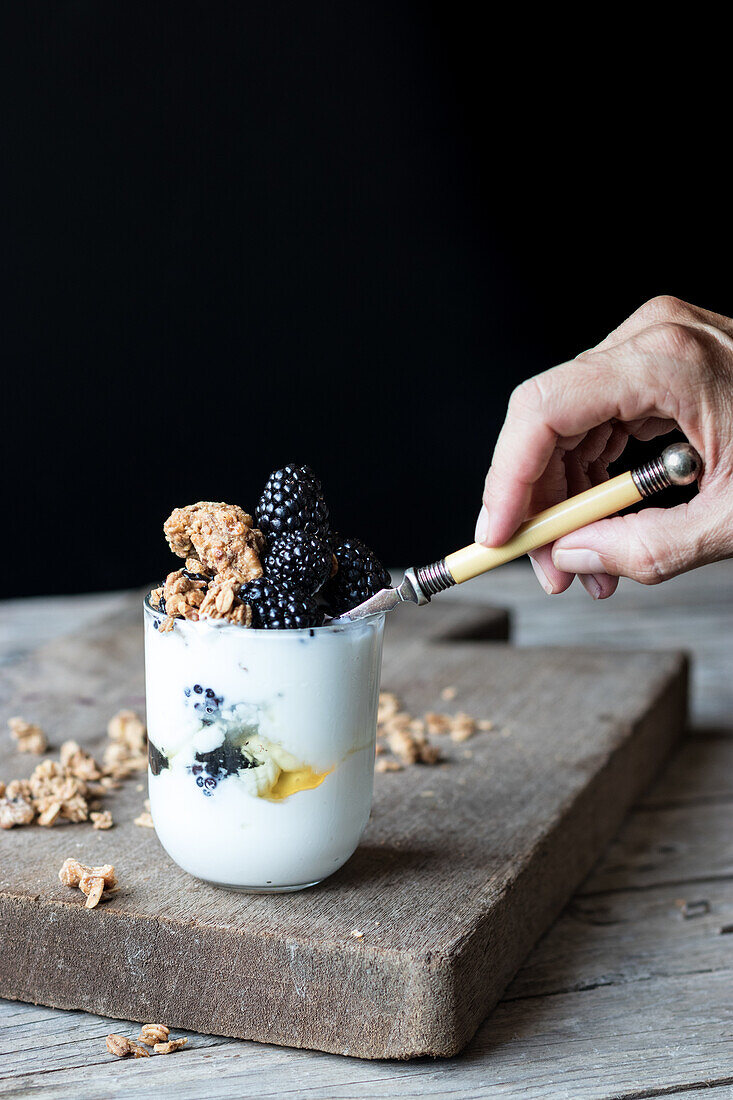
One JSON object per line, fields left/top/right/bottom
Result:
{"left": 475, "top": 296, "right": 733, "bottom": 600}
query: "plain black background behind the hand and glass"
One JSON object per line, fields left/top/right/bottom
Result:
{"left": 0, "top": 0, "right": 731, "bottom": 595}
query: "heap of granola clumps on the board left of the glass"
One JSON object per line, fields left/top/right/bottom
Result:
{"left": 0, "top": 711, "right": 147, "bottom": 829}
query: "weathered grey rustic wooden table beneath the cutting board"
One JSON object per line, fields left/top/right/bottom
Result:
{"left": 0, "top": 562, "right": 733, "bottom": 1100}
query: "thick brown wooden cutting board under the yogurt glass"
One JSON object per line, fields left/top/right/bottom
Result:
{"left": 0, "top": 597, "right": 687, "bottom": 1058}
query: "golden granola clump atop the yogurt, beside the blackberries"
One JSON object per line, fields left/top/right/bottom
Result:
{"left": 150, "top": 501, "right": 265, "bottom": 633}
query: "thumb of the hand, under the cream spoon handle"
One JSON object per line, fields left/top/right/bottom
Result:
{"left": 553, "top": 501, "right": 712, "bottom": 584}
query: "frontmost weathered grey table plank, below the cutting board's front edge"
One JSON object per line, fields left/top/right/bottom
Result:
{"left": 0, "top": 970, "right": 733, "bottom": 1100}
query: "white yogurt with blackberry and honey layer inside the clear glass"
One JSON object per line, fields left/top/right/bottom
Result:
{"left": 140, "top": 603, "right": 384, "bottom": 891}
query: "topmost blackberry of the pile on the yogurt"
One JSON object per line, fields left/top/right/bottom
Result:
{"left": 254, "top": 464, "right": 328, "bottom": 540}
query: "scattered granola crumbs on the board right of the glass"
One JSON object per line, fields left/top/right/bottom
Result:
{"left": 376, "top": 688, "right": 493, "bottom": 772}
